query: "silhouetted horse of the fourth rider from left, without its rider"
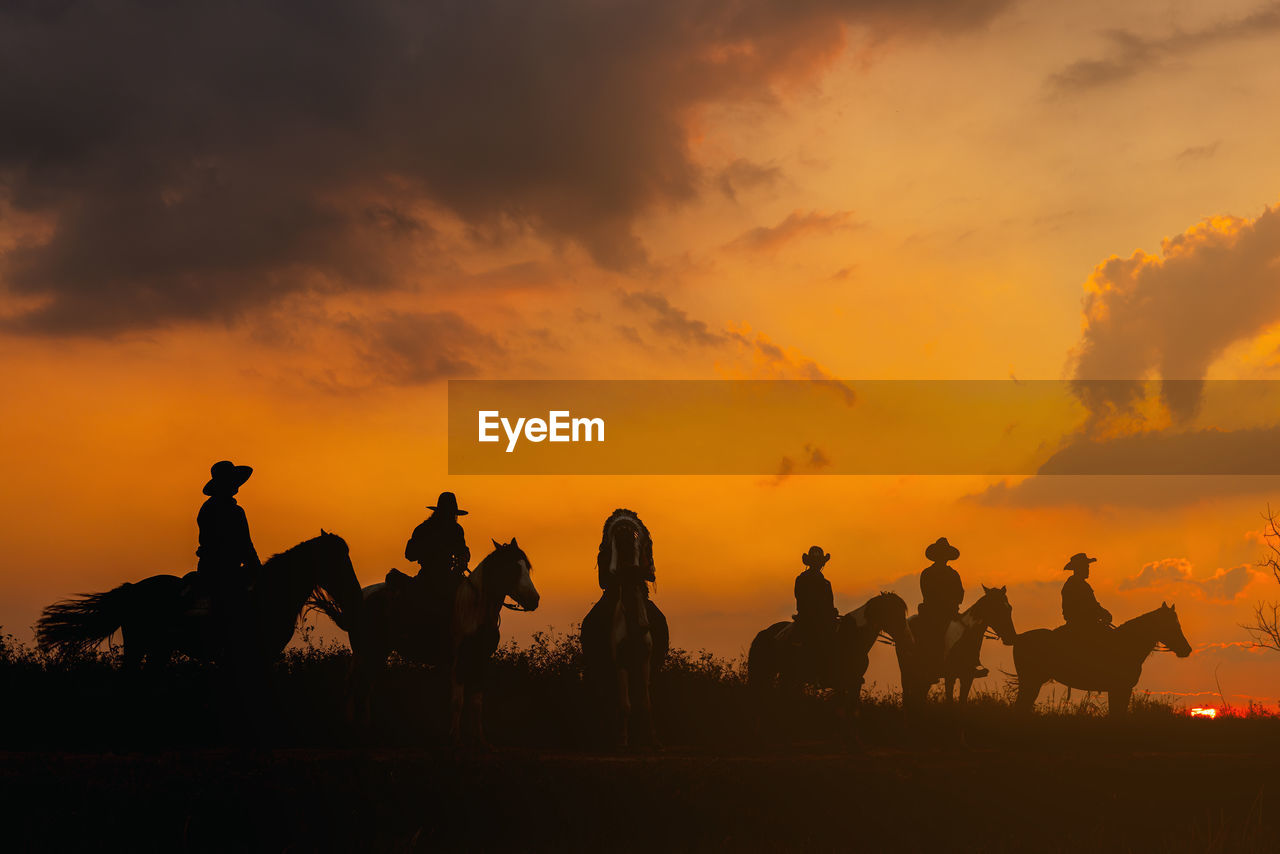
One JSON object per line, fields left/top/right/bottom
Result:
{"left": 746, "top": 593, "right": 914, "bottom": 737}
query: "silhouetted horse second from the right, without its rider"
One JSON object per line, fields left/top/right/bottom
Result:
{"left": 902, "top": 585, "right": 1016, "bottom": 705}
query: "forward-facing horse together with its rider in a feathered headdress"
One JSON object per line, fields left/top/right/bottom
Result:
{"left": 581, "top": 508, "right": 671, "bottom": 748}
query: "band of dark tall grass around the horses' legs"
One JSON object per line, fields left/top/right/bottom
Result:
{"left": 0, "top": 629, "right": 1280, "bottom": 753}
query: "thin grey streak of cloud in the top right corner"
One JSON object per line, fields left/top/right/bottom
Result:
{"left": 1046, "top": 3, "right": 1280, "bottom": 95}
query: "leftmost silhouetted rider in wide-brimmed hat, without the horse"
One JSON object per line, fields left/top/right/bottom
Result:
{"left": 196, "top": 460, "right": 262, "bottom": 612}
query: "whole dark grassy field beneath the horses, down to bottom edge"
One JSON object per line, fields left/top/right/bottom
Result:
{"left": 0, "top": 635, "right": 1280, "bottom": 851}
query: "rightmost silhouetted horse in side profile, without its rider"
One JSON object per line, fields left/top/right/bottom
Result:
{"left": 1014, "top": 603, "right": 1192, "bottom": 717}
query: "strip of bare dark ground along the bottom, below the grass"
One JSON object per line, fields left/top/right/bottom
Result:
{"left": 0, "top": 748, "right": 1280, "bottom": 851}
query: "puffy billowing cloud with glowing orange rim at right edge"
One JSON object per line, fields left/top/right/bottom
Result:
{"left": 1071, "top": 201, "right": 1280, "bottom": 423}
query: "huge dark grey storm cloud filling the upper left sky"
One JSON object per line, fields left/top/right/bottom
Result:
{"left": 0, "top": 0, "right": 1005, "bottom": 334}
